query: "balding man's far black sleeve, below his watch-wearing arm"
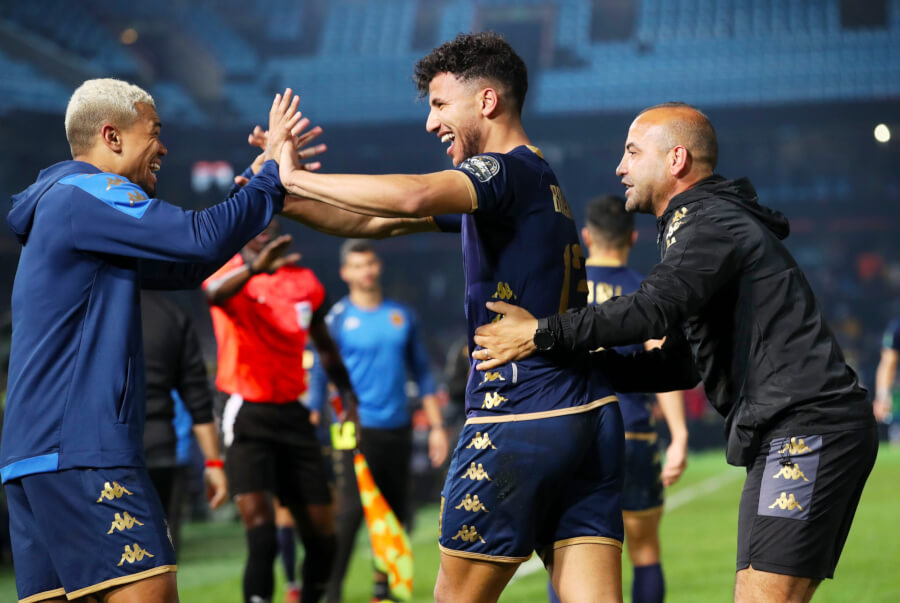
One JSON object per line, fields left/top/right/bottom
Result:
{"left": 591, "top": 331, "right": 700, "bottom": 393}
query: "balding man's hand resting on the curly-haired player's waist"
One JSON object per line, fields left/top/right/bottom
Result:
{"left": 472, "top": 302, "right": 537, "bottom": 371}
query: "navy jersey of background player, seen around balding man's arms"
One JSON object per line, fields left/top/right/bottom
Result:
{"left": 587, "top": 259, "right": 653, "bottom": 433}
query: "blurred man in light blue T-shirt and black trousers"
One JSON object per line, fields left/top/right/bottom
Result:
{"left": 311, "top": 239, "right": 448, "bottom": 603}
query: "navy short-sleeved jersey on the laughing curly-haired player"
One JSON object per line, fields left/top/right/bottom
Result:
{"left": 435, "top": 146, "right": 612, "bottom": 417}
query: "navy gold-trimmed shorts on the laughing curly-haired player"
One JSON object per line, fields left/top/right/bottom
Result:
{"left": 440, "top": 398, "right": 624, "bottom": 563}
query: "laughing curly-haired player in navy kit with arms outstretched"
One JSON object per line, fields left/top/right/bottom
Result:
{"left": 274, "top": 33, "right": 624, "bottom": 601}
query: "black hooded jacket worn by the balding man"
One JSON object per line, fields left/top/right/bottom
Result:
{"left": 542, "top": 175, "right": 873, "bottom": 465}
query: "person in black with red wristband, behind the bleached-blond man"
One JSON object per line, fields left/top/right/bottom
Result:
{"left": 141, "top": 290, "right": 228, "bottom": 553}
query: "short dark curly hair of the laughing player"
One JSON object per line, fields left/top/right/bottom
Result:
{"left": 413, "top": 31, "right": 528, "bottom": 114}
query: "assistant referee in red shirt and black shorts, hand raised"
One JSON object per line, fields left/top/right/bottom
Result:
{"left": 203, "top": 222, "right": 357, "bottom": 603}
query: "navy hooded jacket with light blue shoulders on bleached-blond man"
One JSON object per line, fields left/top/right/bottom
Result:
{"left": 0, "top": 161, "right": 284, "bottom": 482}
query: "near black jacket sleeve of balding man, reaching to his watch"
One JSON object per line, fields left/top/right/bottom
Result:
{"left": 539, "top": 210, "right": 739, "bottom": 352}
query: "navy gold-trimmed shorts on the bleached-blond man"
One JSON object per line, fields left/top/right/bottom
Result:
{"left": 4, "top": 467, "right": 176, "bottom": 603}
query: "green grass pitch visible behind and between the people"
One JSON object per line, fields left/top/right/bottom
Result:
{"left": 0, "top": 444, "right": 900, "bottom": 603}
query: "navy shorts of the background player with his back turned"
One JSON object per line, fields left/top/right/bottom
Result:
{"left": 622, "top": 431, "right": 663, "bottom": 514}
